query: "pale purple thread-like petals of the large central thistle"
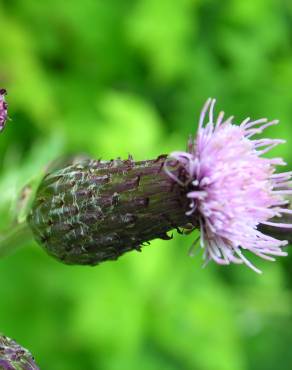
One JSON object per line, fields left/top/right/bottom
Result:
{"left": 165, "top": 99, "right": 292, "bottom": 273}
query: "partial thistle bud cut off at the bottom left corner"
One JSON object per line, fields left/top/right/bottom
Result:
{"left": 0, "top": 335, "right": 39, "bottom": 370}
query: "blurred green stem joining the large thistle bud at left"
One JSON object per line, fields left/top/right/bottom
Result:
{"left": 0, "top": 222, "right": 32, "bottom": 258}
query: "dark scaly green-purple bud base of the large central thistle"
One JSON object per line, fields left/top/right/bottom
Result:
{"left": 28, "top": 156, "right": 192, "bottom": 265}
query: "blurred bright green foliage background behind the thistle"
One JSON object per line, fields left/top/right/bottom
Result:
{"left": 0, "top": 0, "right": 292, "bottom": 370}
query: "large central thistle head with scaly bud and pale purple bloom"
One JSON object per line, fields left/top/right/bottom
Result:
{"left": 28, "top": 99, "right": 292, "bottom": 272}
